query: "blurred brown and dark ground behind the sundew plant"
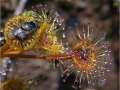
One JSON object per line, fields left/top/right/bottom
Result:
{"left": 0, "top": 0, "right": 120, "bottom": 90}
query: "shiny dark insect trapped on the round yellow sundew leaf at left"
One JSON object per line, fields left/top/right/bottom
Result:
{"left": 8, "top": 22, "right": 38, "bottom": 41}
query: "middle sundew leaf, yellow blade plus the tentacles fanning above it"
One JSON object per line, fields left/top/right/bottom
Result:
{"left": 31, "top": 6, "right": 64, "bottom": 53}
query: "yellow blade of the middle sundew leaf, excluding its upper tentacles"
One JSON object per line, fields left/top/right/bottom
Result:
{"left": 36, "top": 22, "right": 62, "bottom": 53}
